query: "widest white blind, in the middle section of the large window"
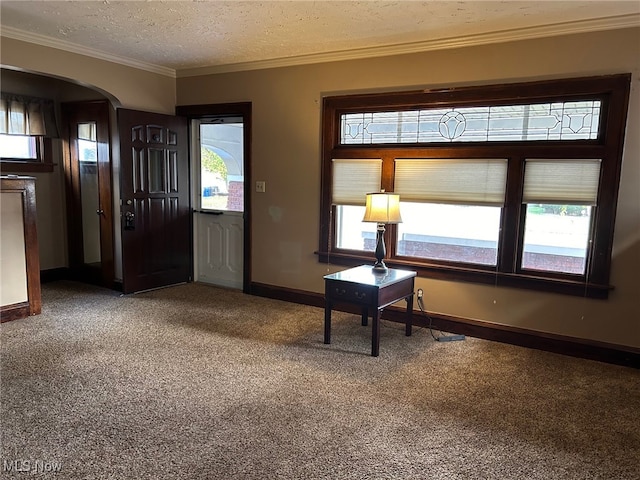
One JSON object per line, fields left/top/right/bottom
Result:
{"left": 394, "top": 158, "right": 507, "bottom": 206}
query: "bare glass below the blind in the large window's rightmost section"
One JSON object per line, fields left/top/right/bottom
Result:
{"left": 522, "top": 204, "right": 592, "bottom": 275}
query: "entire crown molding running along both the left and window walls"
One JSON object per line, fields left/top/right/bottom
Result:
{"left": 1, "top": 13, "right": 640, "bottom": 78}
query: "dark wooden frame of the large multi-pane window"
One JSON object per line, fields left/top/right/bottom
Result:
{"left": 317, "top": 73, "right": 631, "bottom": 298}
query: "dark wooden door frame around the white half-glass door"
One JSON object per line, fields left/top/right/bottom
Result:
{"left": 176, "top": 102, "right": 253, "bottom": 293}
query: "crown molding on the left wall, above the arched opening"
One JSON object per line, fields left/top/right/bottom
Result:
{"left": 0, "top": 25, "right": 176, "bottom": 78}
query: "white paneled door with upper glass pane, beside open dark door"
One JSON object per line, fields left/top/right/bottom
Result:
{"left": 192, "top": 116, "right": 244, "bottom": 289}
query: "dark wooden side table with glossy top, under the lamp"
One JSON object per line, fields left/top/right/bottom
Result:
{"left": 324, "top": 265, "right": 416, "bottom": 357}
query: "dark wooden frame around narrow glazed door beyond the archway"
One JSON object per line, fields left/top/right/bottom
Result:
{"left": 61, "top": 100, "right": 115, "bottom": 289}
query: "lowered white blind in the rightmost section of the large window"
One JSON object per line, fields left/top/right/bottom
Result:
{"left": 522, "top": 159, "right": 601, "bottom": 205}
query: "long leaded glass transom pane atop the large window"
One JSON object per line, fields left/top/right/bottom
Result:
{"left": 340, "top": 100, "right": 601, "bottom": 144}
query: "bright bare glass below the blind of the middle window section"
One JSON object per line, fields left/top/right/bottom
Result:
{"left": 397, "top": 202, "right": 502, "bottom": 265}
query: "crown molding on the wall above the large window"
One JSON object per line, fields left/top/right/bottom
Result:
{"left": 176, "top": 14, "right": 640, "bottom": 78}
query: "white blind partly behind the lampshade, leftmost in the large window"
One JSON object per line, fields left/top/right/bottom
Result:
{"left": 331, "top": 159, "right": 382, "bottom": 206}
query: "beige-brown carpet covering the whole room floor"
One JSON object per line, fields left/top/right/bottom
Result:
{"left": 0, "top": 282, "right": 640, "bottom": 480}
